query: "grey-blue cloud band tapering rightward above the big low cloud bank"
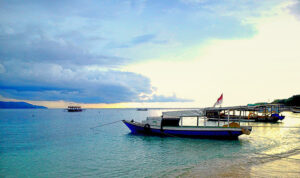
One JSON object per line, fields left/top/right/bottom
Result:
{"left": 0, "top": 27, "right": 129, "bottom": 67}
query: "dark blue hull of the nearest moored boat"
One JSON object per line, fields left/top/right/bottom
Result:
{"left": 123, "top": 120, "right": 248, "bottom": 139}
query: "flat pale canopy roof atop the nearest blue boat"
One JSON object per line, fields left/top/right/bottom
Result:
{"left": 162, "top": 109, "right": 203, "bottom": 119}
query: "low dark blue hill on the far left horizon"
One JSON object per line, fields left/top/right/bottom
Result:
{"left": 0, "top": 101, "right": 47, "bottom": 109}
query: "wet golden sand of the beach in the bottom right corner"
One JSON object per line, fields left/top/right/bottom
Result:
{"left": 175, "top": 149, "right": 300, "bottom": 178}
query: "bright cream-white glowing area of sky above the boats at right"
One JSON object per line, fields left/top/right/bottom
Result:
{"left": 125, "top": 3, "right": 300, "bottom": 106}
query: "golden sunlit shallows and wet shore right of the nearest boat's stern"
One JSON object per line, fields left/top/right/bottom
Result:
{"left": 179, "top": 113, "right": 300, "bottom": 177}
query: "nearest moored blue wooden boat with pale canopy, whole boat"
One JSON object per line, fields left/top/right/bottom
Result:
{"left": 123, "top": 110, "right": 252, "bottom": 139}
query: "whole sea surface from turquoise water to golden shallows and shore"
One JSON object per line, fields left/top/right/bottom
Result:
{"left": 0, "top": 109, "right": 300, "bottom": 177}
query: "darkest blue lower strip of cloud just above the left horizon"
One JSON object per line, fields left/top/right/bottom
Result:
{"left": 0, "top": 85, "right": 139, "bottom": 103}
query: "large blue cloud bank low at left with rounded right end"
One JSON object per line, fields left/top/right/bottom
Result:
{"left": 0, "top": 60, "right": 189, "bottom": 103}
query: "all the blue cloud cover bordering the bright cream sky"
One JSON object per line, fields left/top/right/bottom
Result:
{"left": 0, "top": 0, "right": 286, "bottom": 103}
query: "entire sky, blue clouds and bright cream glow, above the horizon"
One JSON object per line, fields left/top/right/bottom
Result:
{"left": 0, "top": 0, "right": 300, "bottom": 108}
